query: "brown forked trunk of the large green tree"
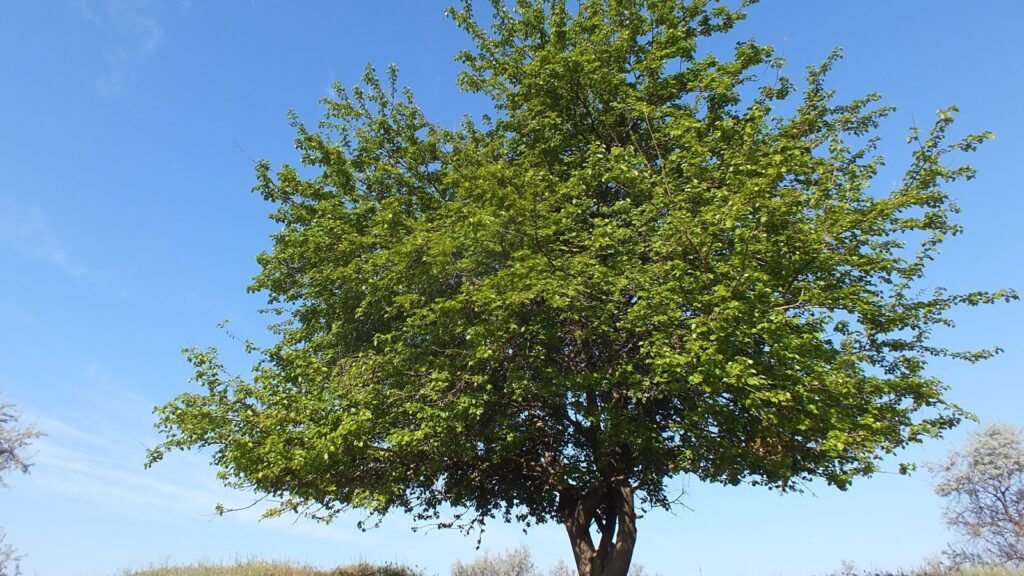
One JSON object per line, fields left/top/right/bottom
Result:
{"left": 559, "top": 485, "right": 637, "bottom": 576}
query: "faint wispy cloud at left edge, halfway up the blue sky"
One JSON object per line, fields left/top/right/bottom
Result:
{"left": 0, "top": 200, "right": 88, "bottom": 278}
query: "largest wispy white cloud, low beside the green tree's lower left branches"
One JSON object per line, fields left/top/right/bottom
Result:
{"left": 26, "top": 363, "right": 354, "bottom": 543}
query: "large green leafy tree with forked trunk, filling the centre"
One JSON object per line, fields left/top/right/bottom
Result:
{"left": 148, "top": 0, "right": 1017, "bottom": 576}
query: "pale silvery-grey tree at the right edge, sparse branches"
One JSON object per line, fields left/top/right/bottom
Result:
{"left": 930, "top": 424, "right": 1024, "bottom": 568}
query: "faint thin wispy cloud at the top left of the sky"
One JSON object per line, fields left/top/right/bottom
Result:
{"left": 79, "top": 0, "right": 165, "bottom": 96}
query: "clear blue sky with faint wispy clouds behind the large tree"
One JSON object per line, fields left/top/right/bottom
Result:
{"left": 0, "top": 0, "right": 1024, "bottom": 576}
